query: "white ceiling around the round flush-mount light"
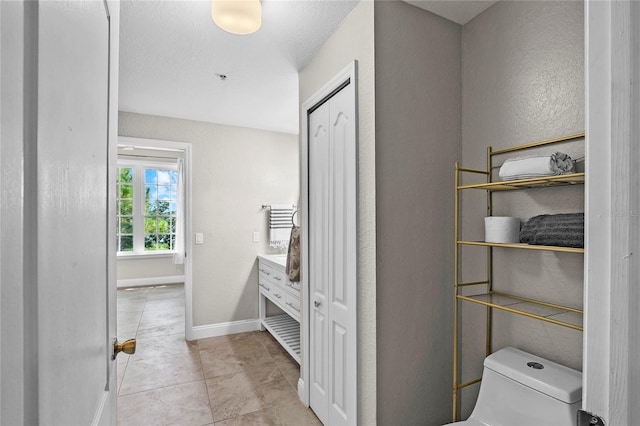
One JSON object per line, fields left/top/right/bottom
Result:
{"left": 119, "top": 0, "right": 495, "bottom": 134}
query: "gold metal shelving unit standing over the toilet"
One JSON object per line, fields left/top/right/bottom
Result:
{"left": 453, "top": 133, "right": 585, "bottom": 422}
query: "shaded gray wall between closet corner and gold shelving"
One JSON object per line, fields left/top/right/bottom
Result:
{"left": 375, "top": 1, "right": 462, "bottom": 425}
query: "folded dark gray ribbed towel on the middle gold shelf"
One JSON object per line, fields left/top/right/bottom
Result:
{"left": 520, "top": 213, "right": 584, "bottom": 248}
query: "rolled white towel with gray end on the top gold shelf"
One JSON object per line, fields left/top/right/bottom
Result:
{"left": 498, "top": 152, "right": 574, "bottom": 180}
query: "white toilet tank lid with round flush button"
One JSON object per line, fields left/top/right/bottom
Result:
{"left": 484, "top": 347, "right": 582, "bottom": 404}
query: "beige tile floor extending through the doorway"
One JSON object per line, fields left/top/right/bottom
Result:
{"left": 118, "top": 285, "right": 321, "bottom": 426}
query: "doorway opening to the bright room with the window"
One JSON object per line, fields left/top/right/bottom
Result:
{"left": 114, "top": 137, "right": 193, "bottom": 376}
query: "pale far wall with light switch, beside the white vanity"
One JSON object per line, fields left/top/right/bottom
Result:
{"left": 119, "top": 112, "right": 300, "bottom": 326}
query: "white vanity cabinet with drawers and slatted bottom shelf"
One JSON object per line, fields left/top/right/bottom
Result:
{"left": 258, "top": 255, "right": 301, "bottom": 364}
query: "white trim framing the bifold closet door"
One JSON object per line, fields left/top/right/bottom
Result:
{"left": 298, "top": 60, "right": 358, "bottom": 422}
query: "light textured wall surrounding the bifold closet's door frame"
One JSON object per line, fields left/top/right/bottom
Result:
{"left": 299, "top": 1, "right": 376, "bottom": 425}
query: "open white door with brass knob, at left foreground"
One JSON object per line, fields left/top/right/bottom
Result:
{"left": 36, "top": 1, "right": 118, "bottom": 425}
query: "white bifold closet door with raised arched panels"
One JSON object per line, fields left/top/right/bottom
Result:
{"left": 308, "top": 82, "right": 357, "bottom": 425}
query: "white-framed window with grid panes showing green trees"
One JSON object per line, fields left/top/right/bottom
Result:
{"left": 116, "top": 161, "right": 178, "bottom": 254}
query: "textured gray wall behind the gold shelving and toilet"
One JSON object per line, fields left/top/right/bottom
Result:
{"left": 461, "top": 1, "right": 585, "bottom": 416}
